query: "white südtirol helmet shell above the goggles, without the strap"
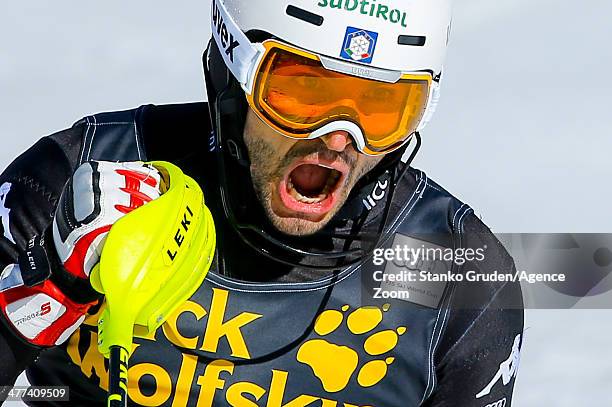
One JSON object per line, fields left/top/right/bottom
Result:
{"left": 219, "top": 0, "right": 451, "bottom": 76}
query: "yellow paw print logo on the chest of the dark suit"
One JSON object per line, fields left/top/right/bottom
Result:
{"left": 297, "top": 304, "right": 406, "bottom": 393}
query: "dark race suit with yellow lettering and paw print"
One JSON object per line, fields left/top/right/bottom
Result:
{"left": 0, "top": 103, "right": 523, "bottom": 407}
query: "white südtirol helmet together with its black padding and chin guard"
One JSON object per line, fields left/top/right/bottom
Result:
{"left": 203, "top": 0, "right": 451, "bottom": 268}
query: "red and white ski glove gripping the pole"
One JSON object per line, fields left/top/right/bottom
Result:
{"left": 0, "top": 161, "right": 161, "bottom": 347}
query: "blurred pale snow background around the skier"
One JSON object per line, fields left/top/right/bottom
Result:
{"left": 0, "top": 0, "right": 612, "bottom": 407}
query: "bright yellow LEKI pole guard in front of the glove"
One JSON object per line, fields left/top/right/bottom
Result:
{"left": 90, "top": 161, "right": 216, "bottom": 357}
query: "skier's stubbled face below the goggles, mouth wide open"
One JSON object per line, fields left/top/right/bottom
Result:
{"left": 244, "top": 109, "right": 382, "bottom": 236}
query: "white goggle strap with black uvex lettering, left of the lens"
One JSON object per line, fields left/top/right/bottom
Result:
{"left": 211, "top": 0, "right": 263, "bottom": 93}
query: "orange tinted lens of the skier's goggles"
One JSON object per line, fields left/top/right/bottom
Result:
{"left": 247, "top": 42, "right": 431, "bottom": 154}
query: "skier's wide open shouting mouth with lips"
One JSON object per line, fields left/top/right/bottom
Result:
{"left": 279, "top": 158, "right": 348, "bottom": 215}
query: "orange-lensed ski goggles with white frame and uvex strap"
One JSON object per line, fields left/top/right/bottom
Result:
{"left": 212, "top": 1, "right": 435, "bottom": 155}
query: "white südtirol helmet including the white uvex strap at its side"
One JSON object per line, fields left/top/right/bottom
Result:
{"left": 211, "top": 0, "right": 451, "bottom": 139}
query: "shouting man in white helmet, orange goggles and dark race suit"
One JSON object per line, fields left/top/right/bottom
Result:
{"left": 0, "top": 0, "right": 523, "bottom": 407}
